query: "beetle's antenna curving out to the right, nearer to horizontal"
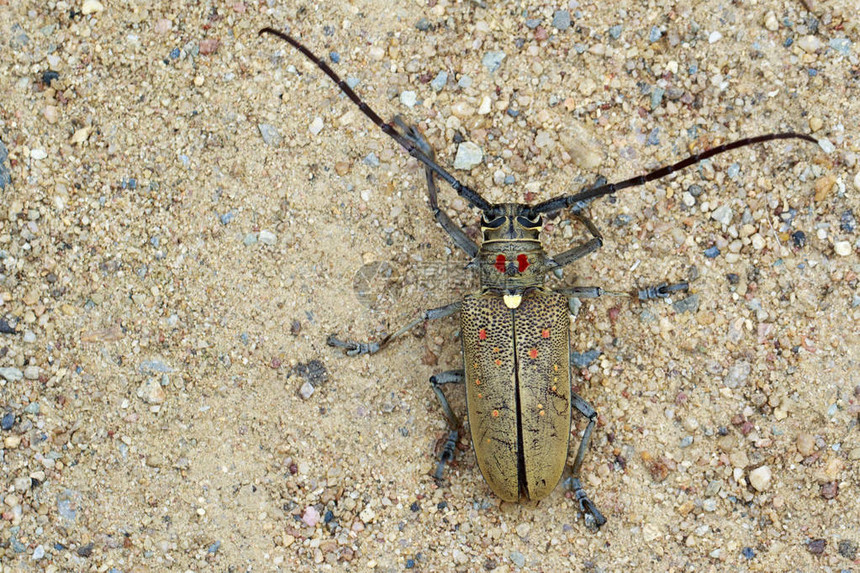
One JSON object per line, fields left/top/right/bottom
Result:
{"left": 531, "top": 132, "right": 818, "bottom": 214}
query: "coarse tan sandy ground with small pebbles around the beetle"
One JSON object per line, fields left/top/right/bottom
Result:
{"left": 0, "top": 0, "right": 860, "bottom": 572}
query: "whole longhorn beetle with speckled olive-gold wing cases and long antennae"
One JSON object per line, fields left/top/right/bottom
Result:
{"left": 260, "top": 28, "right": 818, "bottom": 528}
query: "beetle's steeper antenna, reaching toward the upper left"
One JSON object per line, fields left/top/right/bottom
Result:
{"left": 259, "top": 27, "right": 493, "bottom": 213}
